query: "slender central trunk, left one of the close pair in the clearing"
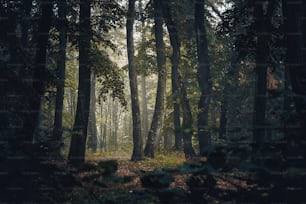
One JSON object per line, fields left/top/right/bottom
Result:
{"left": 126, "top": 0, "right": 143, "bottom": 161}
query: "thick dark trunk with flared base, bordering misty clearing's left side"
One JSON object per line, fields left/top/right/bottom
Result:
{"left": 68, "top": 0, "right": 91, "bottom": 165}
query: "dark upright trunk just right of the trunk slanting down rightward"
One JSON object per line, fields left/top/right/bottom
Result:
{"left": 195, "top": 0, "right": 212, "bottom": 155}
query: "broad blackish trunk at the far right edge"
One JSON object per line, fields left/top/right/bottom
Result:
{"left": 283, "top": 0, "right": 306, "bottom": 168}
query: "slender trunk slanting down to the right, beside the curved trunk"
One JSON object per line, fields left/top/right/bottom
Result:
{"left": 159, "top": 0, "right": 195, "bottom": 159}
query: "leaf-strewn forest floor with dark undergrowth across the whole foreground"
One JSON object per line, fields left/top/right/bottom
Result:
{"left": 0, "top": 152, "right": 306, "bottom": 204}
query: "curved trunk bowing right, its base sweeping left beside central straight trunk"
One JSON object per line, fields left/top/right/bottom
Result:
{"left": 144, "top": 0, "right": 167, "bottom": 158}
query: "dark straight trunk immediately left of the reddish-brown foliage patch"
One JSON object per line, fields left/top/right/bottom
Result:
{"left": 253, "top": 1, "right": 274, "bottom": 151}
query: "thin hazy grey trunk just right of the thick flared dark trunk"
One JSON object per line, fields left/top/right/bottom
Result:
{"left": 87, "top": 73, "right": 98, "bottom": 152}
